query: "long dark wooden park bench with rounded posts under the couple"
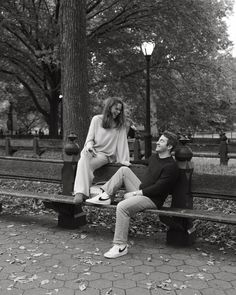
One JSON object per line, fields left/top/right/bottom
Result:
{"left": 0, "top": 140, "right": 236, "bottom": 249}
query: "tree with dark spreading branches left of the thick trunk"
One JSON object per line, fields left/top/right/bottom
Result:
{"left": 0, "top": 0, "right": 61, "bottom": 136}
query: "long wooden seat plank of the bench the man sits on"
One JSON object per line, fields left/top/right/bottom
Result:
{"left": 0, "top": 190, "right": 236, "bottom": 224}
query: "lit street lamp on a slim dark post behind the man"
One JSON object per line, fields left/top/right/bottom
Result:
{"left": 141, "top": 42, "right": 155, "bottom": 159}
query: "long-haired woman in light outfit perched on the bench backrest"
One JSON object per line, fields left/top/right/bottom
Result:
{"left": 74, "top": 97, "right": 130, "bottom": 203}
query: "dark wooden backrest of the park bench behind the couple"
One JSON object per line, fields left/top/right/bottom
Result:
{"left": 0, "top": 157, "right": 236, "bottom": 200}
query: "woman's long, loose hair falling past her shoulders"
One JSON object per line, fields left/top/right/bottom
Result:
{"left": 102, "top": 97, "right": 125, "bottom": 129}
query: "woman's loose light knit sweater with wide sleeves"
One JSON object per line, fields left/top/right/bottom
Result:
{"left": 85, "top": 115, "right": 130, "bottom": 166}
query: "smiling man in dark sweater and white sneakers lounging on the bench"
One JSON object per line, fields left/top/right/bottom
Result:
{"left": 86, "top": 131, "right": 179, "bottom": 258}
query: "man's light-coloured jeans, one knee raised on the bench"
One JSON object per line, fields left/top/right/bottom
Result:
{"left": 102, "top": 167, "right": 156, "bottom": 244}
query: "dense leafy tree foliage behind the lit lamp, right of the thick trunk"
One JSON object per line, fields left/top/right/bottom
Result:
{"left": 85, "top": 1, "right": 235, "bottom": 133}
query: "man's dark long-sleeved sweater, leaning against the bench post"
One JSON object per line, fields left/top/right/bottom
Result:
{"left": 139, "top": 154, "right": 179, "bottom": 208}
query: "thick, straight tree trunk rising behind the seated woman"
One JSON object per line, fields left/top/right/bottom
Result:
{"left": 60, "top": 0, "right": 89, "bottom": 148}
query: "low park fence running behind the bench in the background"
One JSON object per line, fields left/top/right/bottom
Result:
{"left": 0, "top": 136, "right": 236, "bottom": 164}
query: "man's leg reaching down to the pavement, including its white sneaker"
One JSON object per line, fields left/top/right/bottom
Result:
{"left": 104, "top": 196, "right": 156, "bottom": 258}
